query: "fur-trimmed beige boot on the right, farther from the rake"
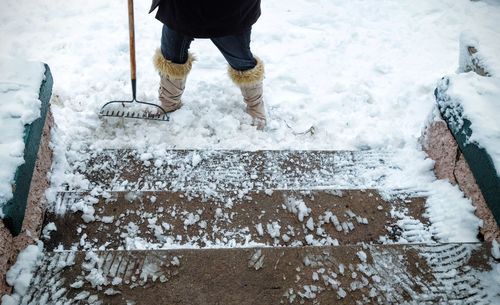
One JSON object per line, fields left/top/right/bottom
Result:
{"left": 229, "top": 57, "right": 266, "bottom": 130}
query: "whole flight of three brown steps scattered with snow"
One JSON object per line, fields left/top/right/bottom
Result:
{"left": 32, "top": 150, "right": 491, "bottom": 305}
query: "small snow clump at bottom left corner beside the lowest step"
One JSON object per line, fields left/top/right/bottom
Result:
{"left": 2, "top": 242, "right": 43, "bottom": 305}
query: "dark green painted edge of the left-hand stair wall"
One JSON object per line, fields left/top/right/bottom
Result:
{"left": 3, "top": 65, "right": 54, "bottom": 236}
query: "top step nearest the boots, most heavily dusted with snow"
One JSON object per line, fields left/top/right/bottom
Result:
{"left": 67, "top": 150, "right": 406, "bottom": 195}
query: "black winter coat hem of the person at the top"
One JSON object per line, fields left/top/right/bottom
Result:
{"left": 149, "top": 0, "right": 260, "bottom": 38}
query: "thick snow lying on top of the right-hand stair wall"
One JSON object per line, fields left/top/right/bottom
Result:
{"left": 454, "top": 28, "right": 500, "bottom": 176}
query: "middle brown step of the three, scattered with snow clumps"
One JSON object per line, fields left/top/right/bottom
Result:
{"left": 45, "top": 190, "right": 431, "bottom": 250}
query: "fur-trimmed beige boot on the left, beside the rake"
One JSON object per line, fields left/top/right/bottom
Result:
{"left": 153, "top": 49, "right": 194, "bottom": 112}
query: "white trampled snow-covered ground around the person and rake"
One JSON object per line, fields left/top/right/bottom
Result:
{"left": 0, "top": 0, "right": 500, "bottom": 236}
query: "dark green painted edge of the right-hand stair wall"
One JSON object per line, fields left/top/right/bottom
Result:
{"left": 434, "top": 77, "right": 500, "bottom": 226}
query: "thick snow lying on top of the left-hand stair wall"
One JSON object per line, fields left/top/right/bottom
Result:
{"left": 0, "top": 55, "right": 45, "bottom": 210}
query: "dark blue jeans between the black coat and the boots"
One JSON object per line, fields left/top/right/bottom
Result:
{"left": 161, "top": 25, "right": 257, "bottom": 71}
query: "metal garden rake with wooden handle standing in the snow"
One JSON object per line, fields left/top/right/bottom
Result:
{"left": 99, "top": 0, "right": 170, "bottom": 121}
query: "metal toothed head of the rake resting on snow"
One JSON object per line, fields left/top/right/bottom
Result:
{"left": 99, "top": 99, "right": 170, "bottom": 121}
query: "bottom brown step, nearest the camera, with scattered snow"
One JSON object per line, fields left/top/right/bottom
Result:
{"left": 21, "top": 243, "right": 494, "bottom": 305}
